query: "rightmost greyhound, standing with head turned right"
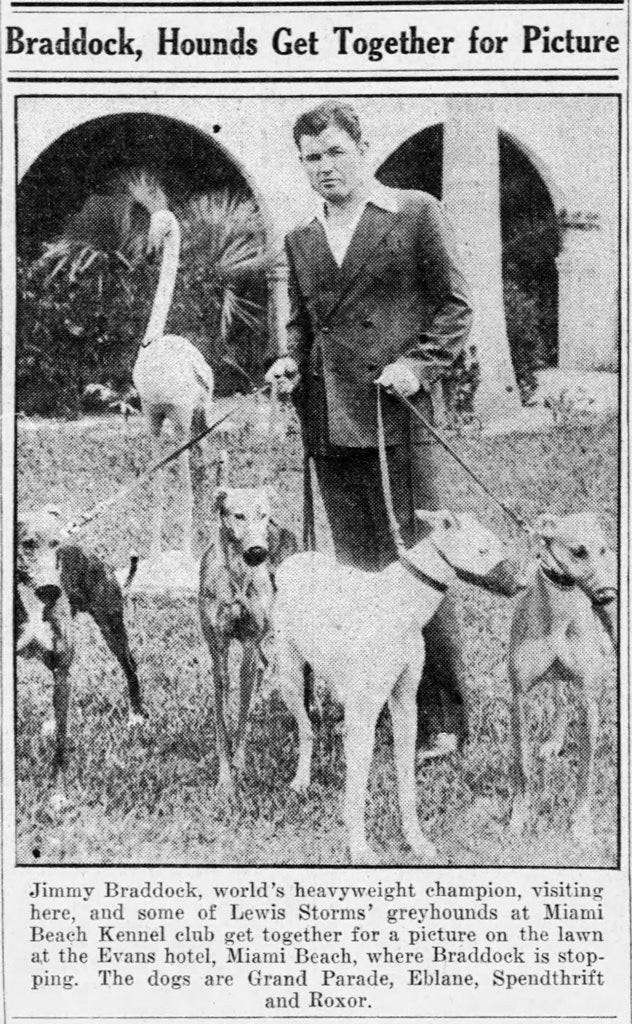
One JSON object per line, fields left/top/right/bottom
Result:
{"left": 508, "top": 513, "right": 617, "bottom": 839}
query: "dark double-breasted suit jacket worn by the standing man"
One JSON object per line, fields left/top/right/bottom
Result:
{"left": 286, "top": 189, "right": 472, "bottom": 454}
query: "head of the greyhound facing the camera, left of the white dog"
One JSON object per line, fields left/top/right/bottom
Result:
{"left": 215, "top": 486, "right": 272, "bottom": 566}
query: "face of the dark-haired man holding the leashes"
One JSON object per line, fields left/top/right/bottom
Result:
{"left": 299, "top": 125, "right": 367, "bottom": 205}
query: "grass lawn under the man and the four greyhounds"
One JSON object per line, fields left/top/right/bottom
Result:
{"left": 16, "top": 402, "right": 618, "bottom": 866}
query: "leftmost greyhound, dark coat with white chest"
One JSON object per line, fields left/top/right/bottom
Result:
{"left": 14, "top": 506, "right": 145, "bottom": 809}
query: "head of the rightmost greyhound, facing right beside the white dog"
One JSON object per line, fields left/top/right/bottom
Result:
{"left": 534, "top": 512, "right": 618, "bottom": 605}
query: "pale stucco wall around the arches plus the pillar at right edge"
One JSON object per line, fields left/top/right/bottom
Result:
{"left": 18, "top": 96, "right": 619, "bottom": 368}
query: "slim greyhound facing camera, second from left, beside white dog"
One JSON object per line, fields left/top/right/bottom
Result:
{"left": 199, "top": 455, "right": 298, "bottom": 793}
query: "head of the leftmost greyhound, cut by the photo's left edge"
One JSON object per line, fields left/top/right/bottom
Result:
{"left": 16, "top": 505, "right": 66, "bottom": 605}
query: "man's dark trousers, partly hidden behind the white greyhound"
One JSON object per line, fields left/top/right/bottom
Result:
{"left": 314, "top": 442, "right": 467, "bottom": 741}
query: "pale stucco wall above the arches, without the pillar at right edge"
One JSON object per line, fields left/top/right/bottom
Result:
{"left": 18, "top": 96, "right": 618, "bottom": 230}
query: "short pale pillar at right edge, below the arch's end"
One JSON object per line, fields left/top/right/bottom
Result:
{"left": 557, "top": 211, "right": 619, "bottom": 370}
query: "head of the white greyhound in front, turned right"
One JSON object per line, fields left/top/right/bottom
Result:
{"left": 416, "top": 509, "right": 526, "bottom": 597}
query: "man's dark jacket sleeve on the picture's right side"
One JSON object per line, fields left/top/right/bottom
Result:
{"left": 398, "top": 200, "right": 473, "bottom": 390}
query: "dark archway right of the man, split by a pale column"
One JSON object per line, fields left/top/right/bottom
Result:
{"left": 377, "top": 124, "right": 560, "bottom": 398}
